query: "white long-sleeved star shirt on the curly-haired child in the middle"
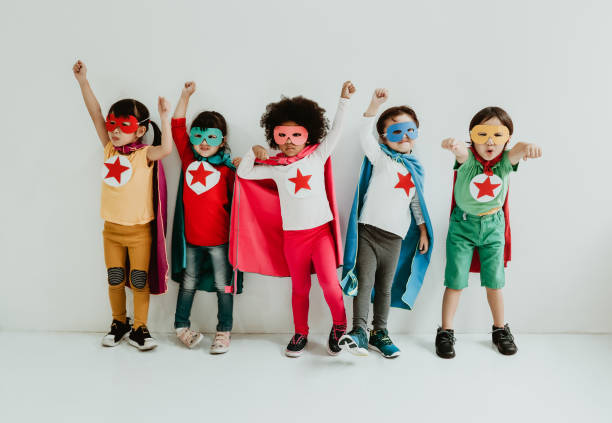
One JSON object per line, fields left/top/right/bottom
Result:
{"left": 237, "top": 98, "right": 348, "bottom": 231}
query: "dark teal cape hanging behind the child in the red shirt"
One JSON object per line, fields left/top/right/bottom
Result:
{"left": 172, "top": 160, "right": 243, "bottom": 294}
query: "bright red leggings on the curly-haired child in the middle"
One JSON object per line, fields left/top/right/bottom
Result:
{"left": 284, "top": 223, "right": 346, "bottom": 335}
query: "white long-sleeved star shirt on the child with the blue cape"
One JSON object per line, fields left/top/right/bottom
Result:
{"left": 359, "top": 117, "right": 424, "bottom": 238}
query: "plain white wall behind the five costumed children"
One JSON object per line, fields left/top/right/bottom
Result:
{"left": 0, "top": 0, "right": 612, "bottom": 333}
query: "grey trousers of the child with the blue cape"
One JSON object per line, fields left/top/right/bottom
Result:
{"left": 353, "top": 223, "right": 402, "bottom": 332}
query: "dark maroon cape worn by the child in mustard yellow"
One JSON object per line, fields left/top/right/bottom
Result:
{"left": 115, "top": 143, "right": 168, "bottom": 295}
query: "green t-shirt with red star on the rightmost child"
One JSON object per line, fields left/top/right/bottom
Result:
{"left": 455, "top": 150, "right": 518, "bottom": 216}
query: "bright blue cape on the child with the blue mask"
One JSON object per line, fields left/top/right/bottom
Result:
{"left": 341, "top": 145, "right": 434, "bottom": 310}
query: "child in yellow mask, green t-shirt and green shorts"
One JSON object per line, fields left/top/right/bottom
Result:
{"left": 436, "top": 107, "right": 542, "bottom": 358}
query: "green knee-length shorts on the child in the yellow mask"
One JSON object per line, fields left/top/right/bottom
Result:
{"left": 444, "top": 207, "right": 506, "bottom": 289}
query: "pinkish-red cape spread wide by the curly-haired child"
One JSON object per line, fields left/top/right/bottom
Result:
{"left": 229, "top": 147, "right": 342, "bottom": 277}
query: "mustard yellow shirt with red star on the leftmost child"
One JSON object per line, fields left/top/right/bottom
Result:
{"left": 100, "top": 142, "right": 155, "bottom": 226}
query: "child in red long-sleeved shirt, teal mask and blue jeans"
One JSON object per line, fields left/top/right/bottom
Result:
{"left": 171, "top": 82, "right": 241, "bottom": 354}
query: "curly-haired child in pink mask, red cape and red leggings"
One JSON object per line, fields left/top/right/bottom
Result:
{"left": 229, "top": 81, "right": 355, "bottom": 357}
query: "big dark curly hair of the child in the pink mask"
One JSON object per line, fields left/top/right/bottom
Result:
{"left": 259, "top": 96, "right": 329, "bottom": 149}
